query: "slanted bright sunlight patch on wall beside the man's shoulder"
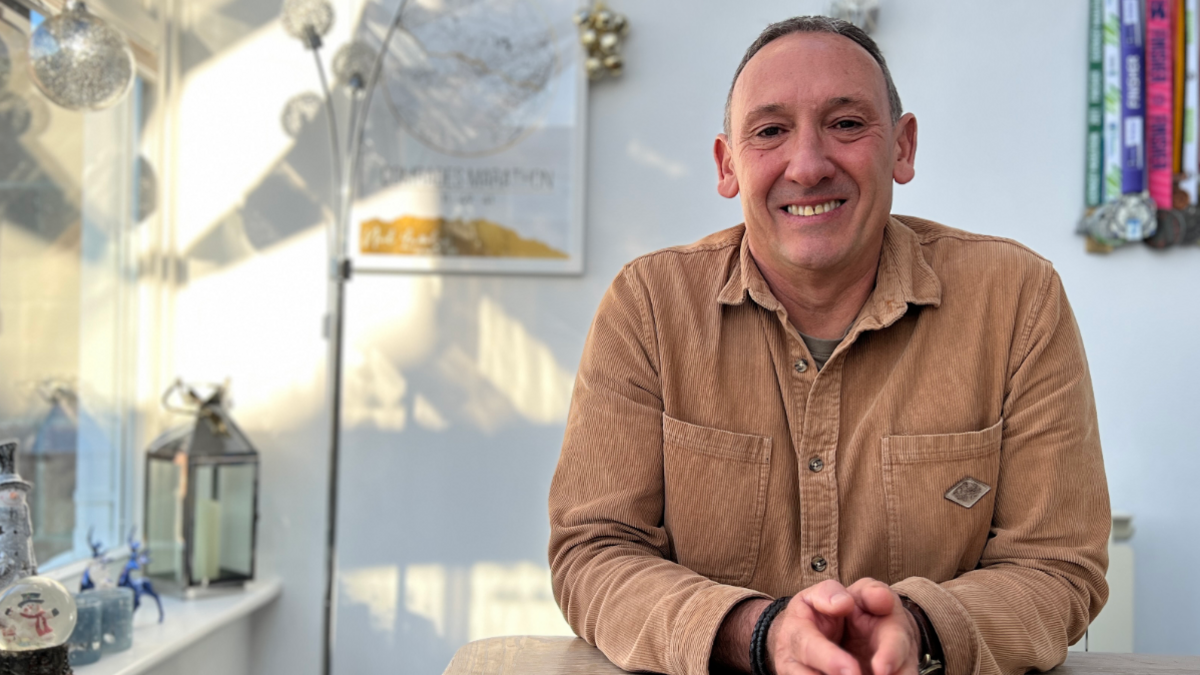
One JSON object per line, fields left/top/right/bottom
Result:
{"left": 478, "top": 297, "right": 575, "bottom": 424}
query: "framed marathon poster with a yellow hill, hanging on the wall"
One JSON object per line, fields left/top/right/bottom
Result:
{"left": 348, "top": 0, "right": 587, "bottom": 274}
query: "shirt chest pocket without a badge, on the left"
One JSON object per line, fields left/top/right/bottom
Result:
{"left": 662, "top": 414, "right": 770, "bottom": 585}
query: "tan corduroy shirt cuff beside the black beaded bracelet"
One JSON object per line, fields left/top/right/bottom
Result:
{"left": 668, "top": 584, "right": 773, "bottom": 675}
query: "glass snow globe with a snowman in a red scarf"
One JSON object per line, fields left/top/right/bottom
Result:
{"left": 0, "top": 577, "right": 76, "bottom": 651}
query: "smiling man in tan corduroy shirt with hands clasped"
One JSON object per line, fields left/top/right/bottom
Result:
{"left": 550, "top": 17, "right": 1110, "bottom": 675}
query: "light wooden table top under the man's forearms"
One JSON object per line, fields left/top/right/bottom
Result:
{"left": 443, "top": 635, "right": 1200, "bottom": 675}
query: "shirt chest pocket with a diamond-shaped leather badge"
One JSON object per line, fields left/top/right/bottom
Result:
{"left": 882, "top": 420, "right": 1003, "bottom": 583}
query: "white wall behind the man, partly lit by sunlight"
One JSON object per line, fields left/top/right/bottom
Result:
{"left": 169, "top": 0, "right": 1200, "bottom": 675}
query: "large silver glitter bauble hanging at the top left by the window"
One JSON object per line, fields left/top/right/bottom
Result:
{"left": 29, "top": 2, "right": 134, "bottom": 110}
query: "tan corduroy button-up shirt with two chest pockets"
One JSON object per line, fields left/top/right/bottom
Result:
{"left": 550, "top": 216, "right": 1111, "bottom": 675}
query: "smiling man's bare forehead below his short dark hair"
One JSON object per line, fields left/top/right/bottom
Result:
{"left": 733, "top": 32, "right": 887, "bottom": 115}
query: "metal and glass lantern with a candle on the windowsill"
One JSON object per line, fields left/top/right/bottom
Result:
{"left": 145, "top": 381, "right": 259, "bottom": 596}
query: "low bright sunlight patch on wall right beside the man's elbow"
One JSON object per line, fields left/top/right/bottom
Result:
{"left": 468, "top": 562, "right": 574, "bottom": 640}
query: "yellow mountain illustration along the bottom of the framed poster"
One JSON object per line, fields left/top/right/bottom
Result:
{"left": 359, "top": 216, "right": 568, "bottom": 258}
